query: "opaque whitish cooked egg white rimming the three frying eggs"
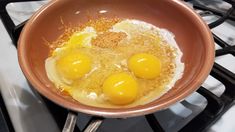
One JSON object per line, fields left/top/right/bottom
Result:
{"left": 45, "top": 19, "right": 184, "bottom": 107}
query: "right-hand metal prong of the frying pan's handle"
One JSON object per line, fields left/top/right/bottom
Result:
{"left": 84, "top": 117, "right": 104, "bottom": 132}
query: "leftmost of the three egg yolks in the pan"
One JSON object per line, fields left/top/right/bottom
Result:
{"left": 56, "top": 53, "right": 91, "bottom": 80}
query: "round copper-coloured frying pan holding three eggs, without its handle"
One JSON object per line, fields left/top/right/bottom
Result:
{"left": 18, "top": 0, "right": 214, "bottom": 131}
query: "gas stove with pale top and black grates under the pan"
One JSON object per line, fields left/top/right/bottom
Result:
{"left": 0, "top": 0, "right": 235, "bottom": 132}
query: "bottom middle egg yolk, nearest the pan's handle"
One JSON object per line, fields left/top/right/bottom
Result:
{"left": 103, "top": 73, "right": 138, "bottom": 105}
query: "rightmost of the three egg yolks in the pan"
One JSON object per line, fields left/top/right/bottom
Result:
{"left": 128, "top": 53, "right": 161, "bottom": 79}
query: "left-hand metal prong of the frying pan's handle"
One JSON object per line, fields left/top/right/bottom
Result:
{"left": 62, "top": 111, "right": 77, "bottom": 132}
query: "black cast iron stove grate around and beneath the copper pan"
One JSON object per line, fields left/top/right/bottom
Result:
{"left": 0, "top": 0, "right": 235, "bottom": 132}
